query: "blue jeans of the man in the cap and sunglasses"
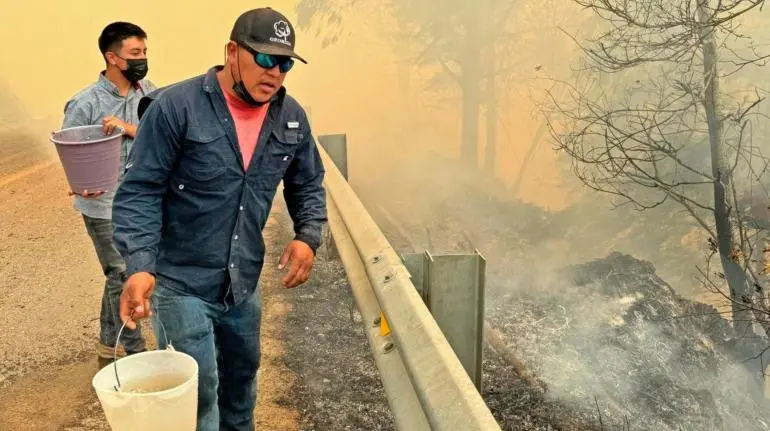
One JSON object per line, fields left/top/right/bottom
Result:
{"left": 152, "top": 276, "right": 262, "bottom": 431}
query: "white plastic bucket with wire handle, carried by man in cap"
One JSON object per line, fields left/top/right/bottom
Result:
{"left": 92, "top": 349, "right": 198, "bottom": 431}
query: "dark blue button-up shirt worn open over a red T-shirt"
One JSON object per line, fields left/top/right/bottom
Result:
{"left": 112, "top": 67, "right": 326, "bottom": 304}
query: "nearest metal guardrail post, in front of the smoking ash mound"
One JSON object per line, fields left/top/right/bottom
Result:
{"left": 402, "top": 250, "right": 486, "bottom": 393}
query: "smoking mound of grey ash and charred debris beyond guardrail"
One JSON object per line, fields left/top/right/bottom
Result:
{"left": 487, "top": 253, "right": 770, "bottom": 430}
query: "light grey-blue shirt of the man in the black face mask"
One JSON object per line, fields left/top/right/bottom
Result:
{"left": 62, "top": 72, "right": 156, "bottom": 219}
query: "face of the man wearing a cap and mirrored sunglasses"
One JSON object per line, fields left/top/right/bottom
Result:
{"left": 227, "top": 42, "right": 286, "bottom": 102}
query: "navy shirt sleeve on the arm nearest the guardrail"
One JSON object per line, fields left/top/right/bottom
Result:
{"left": 283, "top": 126, "right": 327, "bottom": 251}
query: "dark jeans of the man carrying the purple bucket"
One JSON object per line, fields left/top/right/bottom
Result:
{"left": 83, "top": 215, "right": 145, "bottom": 354}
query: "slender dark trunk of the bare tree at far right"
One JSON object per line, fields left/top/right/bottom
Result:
{"left": 698, "top": 0, "right": 751, "bottom": 333}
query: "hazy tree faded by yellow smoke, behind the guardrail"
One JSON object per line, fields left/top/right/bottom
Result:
{"left": 297, "top": 0, "right": 539, "bottom": 172}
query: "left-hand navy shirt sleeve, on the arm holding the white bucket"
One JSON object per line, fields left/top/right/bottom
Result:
{"left": 112, "top": 99, "right": 180, "bottom": 276}
